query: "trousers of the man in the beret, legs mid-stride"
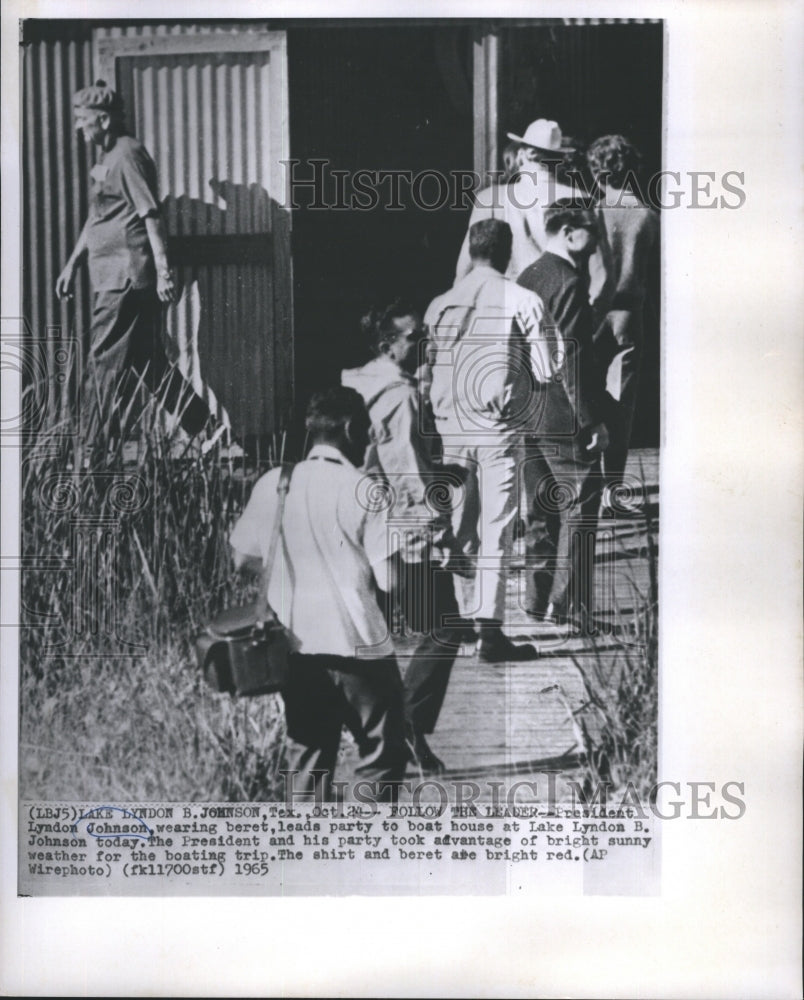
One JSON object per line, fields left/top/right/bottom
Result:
{"left": 81, "top": 288, "right": 210, "bottom": 447}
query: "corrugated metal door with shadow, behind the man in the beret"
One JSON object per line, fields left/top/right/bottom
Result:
{"left": 119, "top": 40, "right": 292, "bottom": 434}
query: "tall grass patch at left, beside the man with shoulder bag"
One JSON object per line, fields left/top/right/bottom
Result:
{"left": 20, "top": 394, "right": 284, "bottom": 802}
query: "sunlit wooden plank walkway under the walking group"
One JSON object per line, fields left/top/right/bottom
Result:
{"left": 340, "top": 449, "right": 659, "bottom": 799}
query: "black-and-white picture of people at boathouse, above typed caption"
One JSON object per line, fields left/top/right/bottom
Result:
{"left": 15, "top": 18, "right": 664, "bottom": 892}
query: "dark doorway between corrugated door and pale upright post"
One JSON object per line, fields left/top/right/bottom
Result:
{"left": 288, "top": 22, "right": 473, "bottom": 422}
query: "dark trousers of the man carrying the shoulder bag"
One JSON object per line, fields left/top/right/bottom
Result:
{"left": 282, "top": 653, "right": 407, "bottom": 802}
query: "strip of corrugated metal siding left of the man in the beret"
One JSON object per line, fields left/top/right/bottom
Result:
{"left": 22, "top": 37, "right": 92, "bottom": 420}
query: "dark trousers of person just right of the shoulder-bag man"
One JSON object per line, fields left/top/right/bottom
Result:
{"left": 396, "top": 555, "right": 460, "bottom": 733}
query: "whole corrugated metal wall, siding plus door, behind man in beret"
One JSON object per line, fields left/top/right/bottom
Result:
{"left": 23, "top": 23, "right": 293, "bottom": 434}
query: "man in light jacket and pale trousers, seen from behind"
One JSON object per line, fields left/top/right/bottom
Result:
{"left": 425, "top": 219, "right": 551, "bottom": 663}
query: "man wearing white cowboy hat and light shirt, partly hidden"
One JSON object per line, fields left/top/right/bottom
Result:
{"left": 455, "top": 118, "right": 592, "bottom": 281}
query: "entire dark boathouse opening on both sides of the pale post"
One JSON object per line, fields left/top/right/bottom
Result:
{"left": 288, "top": 21, "right": 663, "bottom": 446}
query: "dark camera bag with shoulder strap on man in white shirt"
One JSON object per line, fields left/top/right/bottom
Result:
{"left": 194, "top": 465, "right": 293, "bottom": 697}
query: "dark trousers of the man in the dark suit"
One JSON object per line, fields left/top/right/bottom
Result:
{"left": 525, "top": 437, "right": 602, "bottom": 618}
